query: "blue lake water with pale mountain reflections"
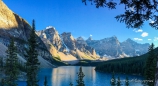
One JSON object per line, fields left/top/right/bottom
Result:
{"left": 18, "top": 66, "right": 143, "bottom": 86}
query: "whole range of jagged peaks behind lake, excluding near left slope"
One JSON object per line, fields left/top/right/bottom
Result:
{"left": 36, "top": 26, "right": 149, "bottom": 61}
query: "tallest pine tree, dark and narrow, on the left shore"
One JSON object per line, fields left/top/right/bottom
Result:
{"left": 25, "top": 20, "right": 40, "bottom": 86}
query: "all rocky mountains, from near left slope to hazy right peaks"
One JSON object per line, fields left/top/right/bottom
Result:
{"left": 0, "top": 0, "right": 149, "bottom": 67}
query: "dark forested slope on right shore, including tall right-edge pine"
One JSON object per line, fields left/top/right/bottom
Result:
{"left": 95, "top": 43, "right": 158, "bottom": 86}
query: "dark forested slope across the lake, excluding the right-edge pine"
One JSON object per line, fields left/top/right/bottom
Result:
{"left": 95, "top": 57, "right": 146, "bottom": 75}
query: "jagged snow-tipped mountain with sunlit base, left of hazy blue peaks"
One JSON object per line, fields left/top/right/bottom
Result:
{"left": 36, "top": 26, "right": 98, "bottom": 61}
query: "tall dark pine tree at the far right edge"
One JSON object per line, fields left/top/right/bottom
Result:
{"left": 145, "top": 43, "right": 156, "bottom": 86}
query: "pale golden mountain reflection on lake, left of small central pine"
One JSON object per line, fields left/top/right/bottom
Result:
{"left": 52, "top": 66, "right": 86, "bottom": 86}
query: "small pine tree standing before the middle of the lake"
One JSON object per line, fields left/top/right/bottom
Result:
{"left": 76, "top": 67, "right": 85, "bottom": 86}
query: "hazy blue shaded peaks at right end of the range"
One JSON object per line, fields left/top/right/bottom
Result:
{"left": 86, "top": 36, "right": 149, "bottom": 58}
